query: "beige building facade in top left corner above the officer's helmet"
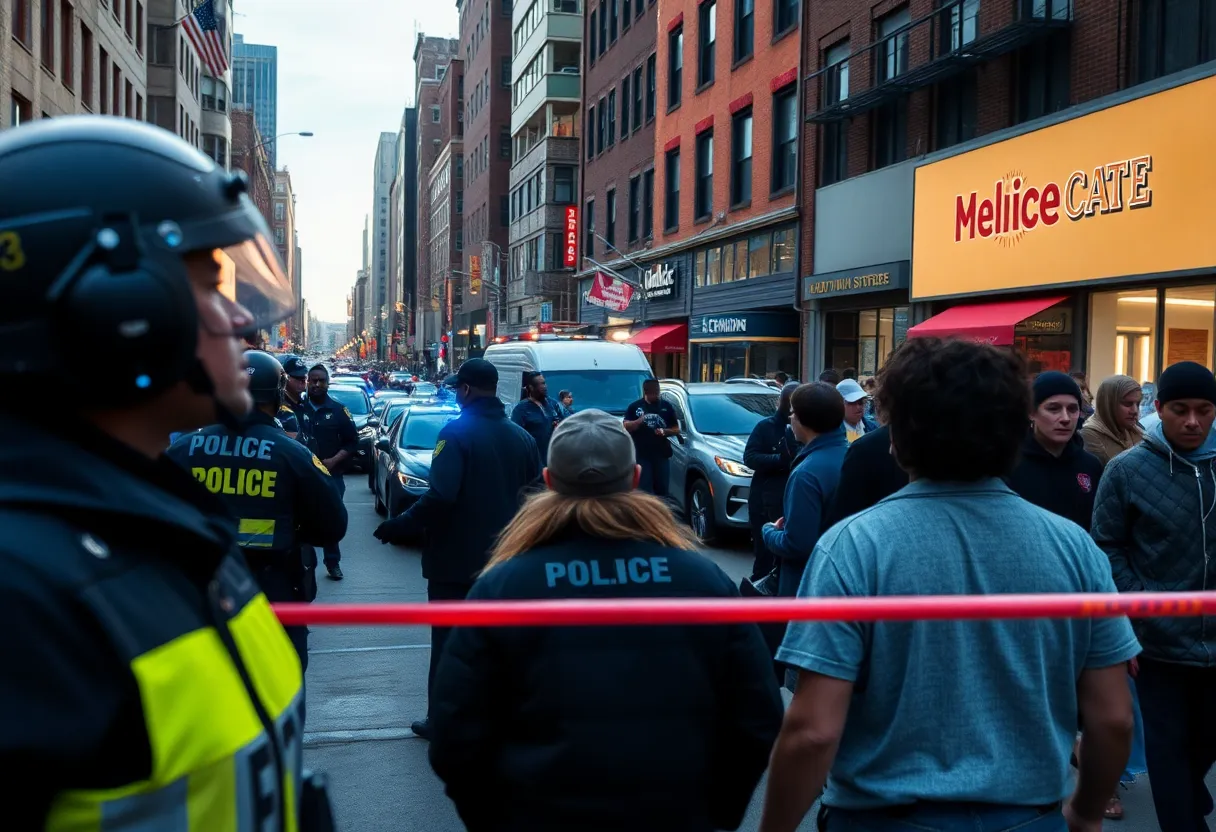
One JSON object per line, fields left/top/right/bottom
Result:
{"left": 0, "top": 0, "right": 147, "bottom": 128}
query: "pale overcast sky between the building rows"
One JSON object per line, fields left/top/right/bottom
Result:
{"left": 233, "top": 0, "right": 458, "bottom": 321}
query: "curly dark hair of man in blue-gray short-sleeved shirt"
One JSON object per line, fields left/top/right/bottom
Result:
{"left": 877, "top": 338, "right": 1030, "bottom": 482}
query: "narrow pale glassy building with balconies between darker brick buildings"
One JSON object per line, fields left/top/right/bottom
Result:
{"left": 505, "top": 0, "right": 582, "bottom": 333}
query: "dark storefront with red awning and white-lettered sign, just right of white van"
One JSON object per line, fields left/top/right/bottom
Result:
{"left": 579, "top": 254, "right": 692, "bottom": 381}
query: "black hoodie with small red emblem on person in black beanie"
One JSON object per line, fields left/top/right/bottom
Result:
{"left": 1006, "top": 432, "right": 1102, "bottom": 532}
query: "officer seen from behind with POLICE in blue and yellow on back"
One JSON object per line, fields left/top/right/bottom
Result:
{"left": 168, "top": 350, "right": 347, "bottom": 670}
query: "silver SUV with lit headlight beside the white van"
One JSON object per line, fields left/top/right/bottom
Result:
{"left": 659, "top": 378, "right": 781, "bottom": 543}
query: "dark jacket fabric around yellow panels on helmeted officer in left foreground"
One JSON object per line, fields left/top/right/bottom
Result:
{"left": 0, "top": 414, "right": 302, "bottom": 830}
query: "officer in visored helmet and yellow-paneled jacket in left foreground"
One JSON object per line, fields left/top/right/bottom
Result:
{"left": 0, "top": 116, "right": 323, "bottom": 832}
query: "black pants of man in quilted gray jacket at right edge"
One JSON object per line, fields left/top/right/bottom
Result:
{"left": 1136, "top": 658, "right": 1216, "bottom": 832}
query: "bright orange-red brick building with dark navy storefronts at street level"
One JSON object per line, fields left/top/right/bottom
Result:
{"left": 631, "top": 0, "right": 801, "bottom": 381}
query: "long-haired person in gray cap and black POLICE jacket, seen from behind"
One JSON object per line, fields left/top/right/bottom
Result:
{"left": 430, "top": 410, "right": 782, "bottom": 832}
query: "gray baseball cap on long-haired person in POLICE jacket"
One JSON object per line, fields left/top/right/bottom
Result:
{"left": 548, "top": 410, "right": 637, "bottom": 496}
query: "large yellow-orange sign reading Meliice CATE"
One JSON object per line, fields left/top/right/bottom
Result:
{"left": 912, "top": 77, "right": 1216, "bottom": 300}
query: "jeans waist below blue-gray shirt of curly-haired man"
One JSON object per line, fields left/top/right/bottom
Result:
{"left": 820, "top": 803, "right": 1068, "bottom": 832}
